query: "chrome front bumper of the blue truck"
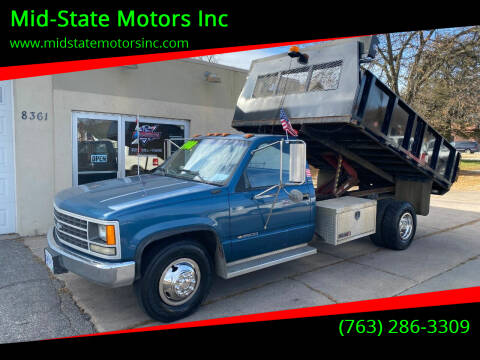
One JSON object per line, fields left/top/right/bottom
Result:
{"left": 47, "top": 227, "right": 135, "bottom": 287}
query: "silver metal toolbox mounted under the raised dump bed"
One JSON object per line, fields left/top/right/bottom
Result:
{"left": 315, "top": 196, "right": 377, "bottom": 245}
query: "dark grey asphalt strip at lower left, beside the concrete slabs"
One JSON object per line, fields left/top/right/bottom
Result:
{"left": 0, "top": 235, "right": 96, "bottom": 343}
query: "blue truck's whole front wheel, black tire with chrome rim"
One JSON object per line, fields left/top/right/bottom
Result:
{"left": 134, "top": 240, "right": 213, "bottom": 322}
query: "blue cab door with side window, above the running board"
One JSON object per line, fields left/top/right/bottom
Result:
{"left": 230, "top": 144, "right": 313, "bottom": 261}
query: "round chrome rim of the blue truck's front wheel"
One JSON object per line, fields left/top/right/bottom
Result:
{"left": 158, "top": 258, "right": 200, "bottom": 306}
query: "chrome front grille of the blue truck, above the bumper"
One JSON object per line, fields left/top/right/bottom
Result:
{"left": 53, "top": 207, "right": 120, "bottom": 259}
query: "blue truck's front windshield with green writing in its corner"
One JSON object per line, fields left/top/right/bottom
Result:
{"left": 154, "top": 139, "right": 248, "bottom": 185}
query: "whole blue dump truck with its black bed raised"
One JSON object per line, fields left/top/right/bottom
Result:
{"left": 45, "top": 38, "right": 460, "bottom": 322}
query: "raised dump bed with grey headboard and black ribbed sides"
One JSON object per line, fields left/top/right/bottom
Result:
{"left": 232, "top": 40, "right": 460, "bottom": 194}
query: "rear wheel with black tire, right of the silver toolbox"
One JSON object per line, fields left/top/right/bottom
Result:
{"left": 382, "top": 201, "right": 417, "bottom": 250}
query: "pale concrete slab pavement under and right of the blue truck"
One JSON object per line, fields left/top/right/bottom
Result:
{"left": 19, "top": 191, "right": 480, "bottom": 332}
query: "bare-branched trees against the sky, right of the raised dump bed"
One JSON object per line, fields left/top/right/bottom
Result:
{"left": 367, "top": 26, "right": 480, "bottom": 138}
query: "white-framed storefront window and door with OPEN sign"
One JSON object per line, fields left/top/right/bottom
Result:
{"left": 73, "top": 111, "right": 189, "bottom": 185}
